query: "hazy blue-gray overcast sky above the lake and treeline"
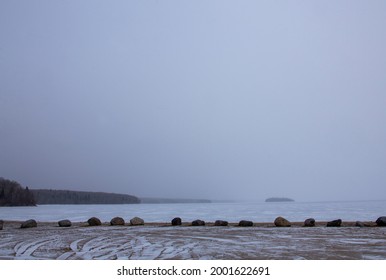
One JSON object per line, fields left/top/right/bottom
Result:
{"left": 0, "top": 0, "right": 386, "bottom": 201}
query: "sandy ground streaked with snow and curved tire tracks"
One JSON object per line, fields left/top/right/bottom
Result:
{"left": 0, "top": 221, "right": 386, "bottom": 260}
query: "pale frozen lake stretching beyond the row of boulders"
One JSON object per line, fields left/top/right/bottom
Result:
{"left": 0, "top": 201, "right": 386, "bottom": 222}
